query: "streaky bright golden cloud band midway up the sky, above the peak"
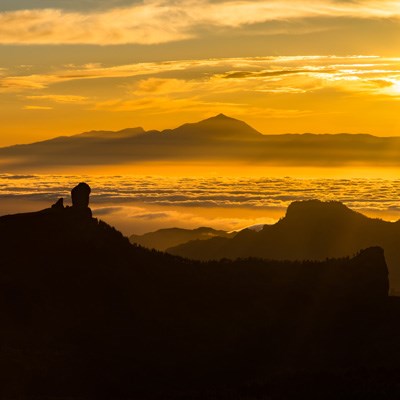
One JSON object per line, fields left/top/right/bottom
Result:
{"left": 0, "top": 56, "right": 400, "bottom": 103}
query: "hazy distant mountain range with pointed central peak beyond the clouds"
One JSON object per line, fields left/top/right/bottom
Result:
{"left": 0, "top": 114, "right": 400, "bottom": 172}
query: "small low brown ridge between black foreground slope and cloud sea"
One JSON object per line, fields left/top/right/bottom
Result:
{"left": 129, "top": 227, "right": 236, "bottom": 251}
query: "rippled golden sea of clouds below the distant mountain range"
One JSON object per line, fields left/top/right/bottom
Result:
{"left": 0, "top": 175, "right": 400, "bottom": 234}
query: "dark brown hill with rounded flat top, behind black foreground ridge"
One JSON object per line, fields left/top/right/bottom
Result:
{"left": 167, "top": 200, "right": 400, "bottom": 291}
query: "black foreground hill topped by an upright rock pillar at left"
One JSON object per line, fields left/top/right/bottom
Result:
{"left": 0, "top": 184, "right": 400, "bottom": 399}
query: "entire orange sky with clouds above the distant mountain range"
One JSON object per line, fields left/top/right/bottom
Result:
{"left": 0, "top": 0, "right": 400, "bottom": 146}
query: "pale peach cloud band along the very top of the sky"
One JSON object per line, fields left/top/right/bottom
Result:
{"left": 0, "top": 0, "right": 400, "bottom": 45}
